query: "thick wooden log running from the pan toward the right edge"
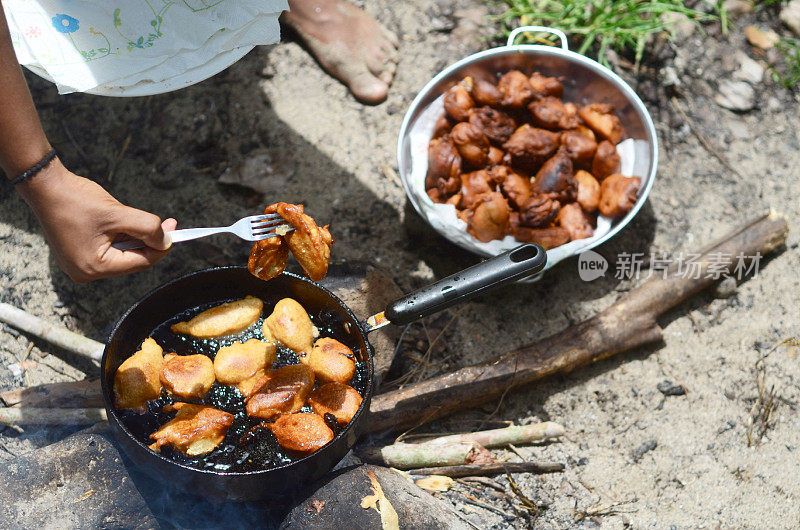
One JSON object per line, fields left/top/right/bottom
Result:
{"left": 365, "top": 212, "right": 789, "bottom": 433}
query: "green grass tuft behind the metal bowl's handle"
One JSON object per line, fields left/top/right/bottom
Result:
{"left": 501, "top": 0, "right": 728, "bottom": 66}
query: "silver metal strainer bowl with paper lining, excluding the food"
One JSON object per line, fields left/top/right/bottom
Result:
{"left": 397, "top": 26, "right": 658, "bottom": 270}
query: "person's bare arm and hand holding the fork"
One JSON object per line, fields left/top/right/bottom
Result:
{"left": 0, "top": 3, "right": 177, "bottom": 282}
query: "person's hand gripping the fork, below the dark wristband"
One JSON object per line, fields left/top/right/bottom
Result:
{"left": 17, "top": 159, "right": 177, "bottom": 283}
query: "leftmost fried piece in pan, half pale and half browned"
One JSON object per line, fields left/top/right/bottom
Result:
{"left": 114, "top": 338, "right": 164, "bottom": 414}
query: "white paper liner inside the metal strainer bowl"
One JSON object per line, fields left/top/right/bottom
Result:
{"left": 409, "top": 95, "right": 647, "bottom": 268}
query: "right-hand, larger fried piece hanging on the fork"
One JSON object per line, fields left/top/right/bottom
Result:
{"left": 276, "top": 202, "right": 333, "bottom": 282}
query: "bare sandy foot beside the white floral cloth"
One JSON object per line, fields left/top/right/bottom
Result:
{"left": 281, "top": 0, "right": 398, "bottom": 104}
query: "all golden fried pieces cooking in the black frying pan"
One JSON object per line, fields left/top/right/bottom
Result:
{"left": 114, "top": 296, "right": 361, "bottom": 456}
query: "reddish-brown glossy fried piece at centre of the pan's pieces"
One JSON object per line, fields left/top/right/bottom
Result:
{"left": 246, "top": 364, "right": 314, "bottom": 419}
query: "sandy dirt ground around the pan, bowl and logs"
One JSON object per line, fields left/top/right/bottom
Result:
{"left": 0, "top": 0, "right": 800, "bottom": 528}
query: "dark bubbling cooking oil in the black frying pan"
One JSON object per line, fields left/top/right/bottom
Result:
{"left": 118, "top": 294, "right": 367, "bottom": 473}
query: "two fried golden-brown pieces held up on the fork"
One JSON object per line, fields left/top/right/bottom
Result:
{"left": 252, "top": 202, "right": 333, "bottom": 281}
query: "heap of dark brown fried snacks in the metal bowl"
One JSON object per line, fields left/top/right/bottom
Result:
{"left": 425, "top": 70, "right": 641, "bottom": 248}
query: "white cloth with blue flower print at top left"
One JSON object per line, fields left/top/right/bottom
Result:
{"left": 3, "top": 0, "right": 289, "bottom": 95}
